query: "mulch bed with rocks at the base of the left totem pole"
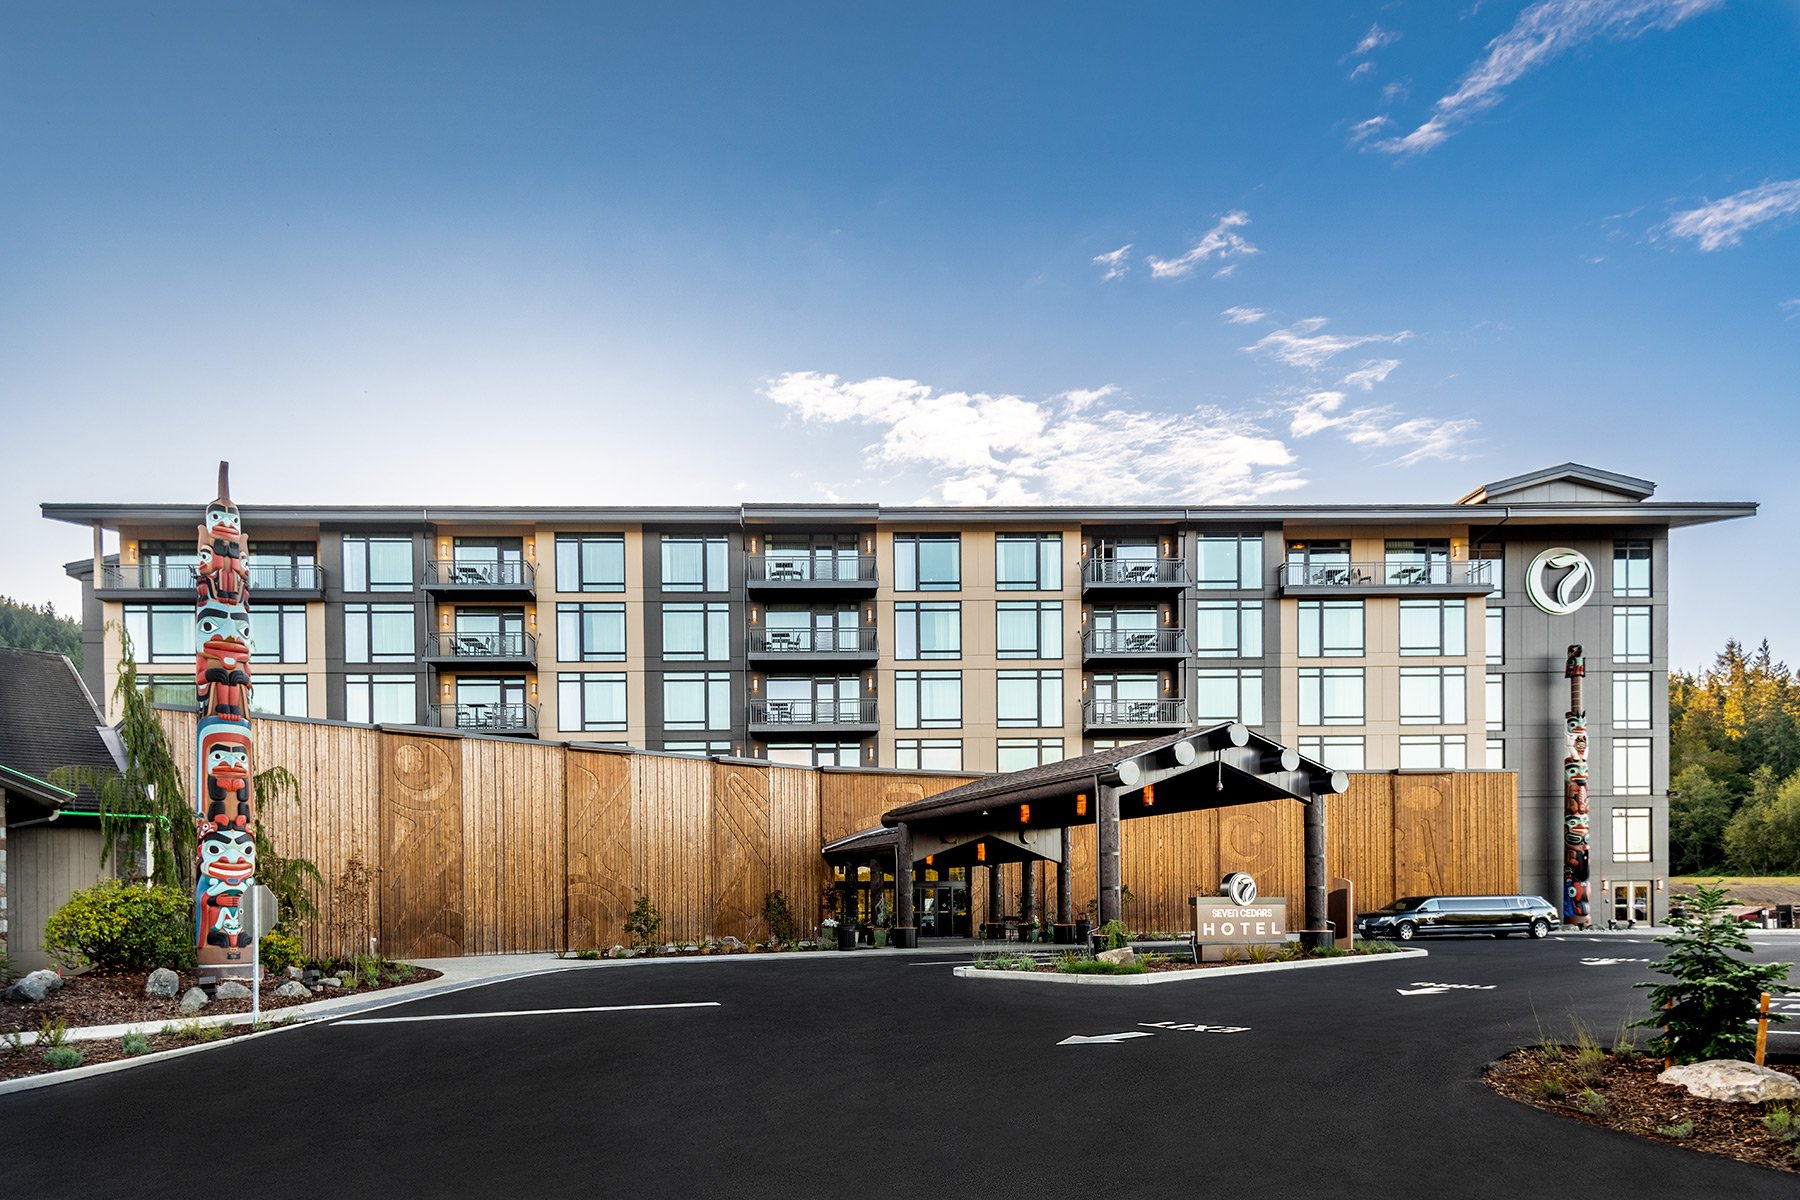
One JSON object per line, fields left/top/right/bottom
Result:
{"left": 0, "top": 966, "right": 441, "bottom": 1079}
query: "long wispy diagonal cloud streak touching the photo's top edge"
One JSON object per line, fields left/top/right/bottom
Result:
{"left": 1375, "top": 0, "right": 1724, "bottom": 155}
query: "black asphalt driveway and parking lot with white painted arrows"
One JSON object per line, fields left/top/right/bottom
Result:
{"left": 0, "top": 937, "right": 1800, "bottom": 1200}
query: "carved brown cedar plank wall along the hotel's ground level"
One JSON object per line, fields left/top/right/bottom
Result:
{"left": 162, "top": 711, "right": 1519, "bottom": 957}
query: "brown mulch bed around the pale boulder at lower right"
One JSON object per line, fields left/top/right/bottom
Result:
{"left": 1487, "top": 1047, "right": 1800, "bottom": 1173}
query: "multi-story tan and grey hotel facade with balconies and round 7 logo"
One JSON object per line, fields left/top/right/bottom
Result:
{"left": 43, "top": 464, "right": 1757, "bottom": 919}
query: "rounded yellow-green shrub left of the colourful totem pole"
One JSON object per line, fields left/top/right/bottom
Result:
{"left": 43, "top": 880, "right": 194, "bottom": 972}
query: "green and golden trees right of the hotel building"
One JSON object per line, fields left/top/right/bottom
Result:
{"left": 1669, "top": 640, "right": 1800, "bottom": 874}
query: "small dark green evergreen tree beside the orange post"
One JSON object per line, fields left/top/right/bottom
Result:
{"left": 1634, "top": 883, "right": 1789, "bottom": 1063}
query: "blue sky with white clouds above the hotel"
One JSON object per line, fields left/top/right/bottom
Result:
{"left": 0, "top": 0, "right": 1800, "bottom": 666}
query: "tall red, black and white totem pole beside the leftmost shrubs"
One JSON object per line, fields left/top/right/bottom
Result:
{"left": 194, "top": 462, "right": 256, "bottom": 979}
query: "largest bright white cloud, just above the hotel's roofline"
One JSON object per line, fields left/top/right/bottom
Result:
{"left": 763, "top": 371, "right": 1303, "bottom": 504}
